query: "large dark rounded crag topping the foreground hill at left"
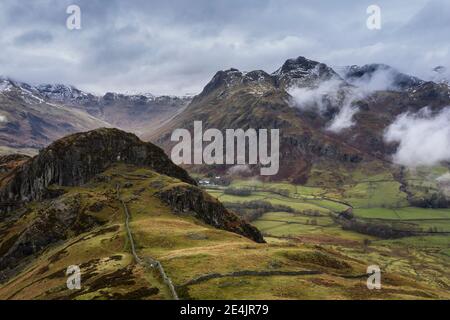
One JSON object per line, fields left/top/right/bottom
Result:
{"left": 0, "top": 128, "right": 196, "bottom": 212}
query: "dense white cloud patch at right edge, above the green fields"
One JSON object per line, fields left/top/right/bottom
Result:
{"left": 384, "top": 107, "right": 450, "bottom": 167}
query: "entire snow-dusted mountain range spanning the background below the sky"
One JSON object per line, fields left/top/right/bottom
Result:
{"left": 0, "top": 56, "right": 450, "bottom": 176}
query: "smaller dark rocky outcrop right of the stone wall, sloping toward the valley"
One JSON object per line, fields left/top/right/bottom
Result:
{"left": 158, "top": 184, "right": 265, "bottom": 243}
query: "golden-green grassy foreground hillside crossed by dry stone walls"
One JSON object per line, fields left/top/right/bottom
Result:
{"left": 0, "top": 165, "right": 450, "bottom": 299}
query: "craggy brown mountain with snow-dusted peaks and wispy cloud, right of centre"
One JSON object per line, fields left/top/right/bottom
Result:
{"left": 148, "top": 57, "right": 450, "bottom": 183}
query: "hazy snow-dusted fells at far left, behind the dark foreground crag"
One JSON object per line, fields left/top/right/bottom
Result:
{"left": 0, "top": 77, "right": 190, "bottom": 154}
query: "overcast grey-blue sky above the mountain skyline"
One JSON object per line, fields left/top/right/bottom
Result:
{"left": 0, "top": 0, "right": 450, "bottom": 95}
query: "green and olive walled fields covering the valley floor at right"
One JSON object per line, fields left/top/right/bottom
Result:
{"left": 202, "top": 173, "right": 450, "bottom": 298}
